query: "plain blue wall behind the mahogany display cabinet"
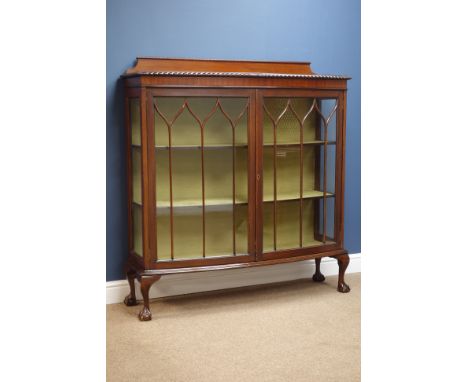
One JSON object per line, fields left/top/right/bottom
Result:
{"left": 106, "top": 0, "right": 361, "bottom": 281}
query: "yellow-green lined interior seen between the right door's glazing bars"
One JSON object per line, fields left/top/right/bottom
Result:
{"left": 263, "top": 98, "right": 336, "bottom": 252}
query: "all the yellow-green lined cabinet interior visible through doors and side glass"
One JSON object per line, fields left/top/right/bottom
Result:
{"left": 131, "top": 97, "right": 336, "bottom": 260}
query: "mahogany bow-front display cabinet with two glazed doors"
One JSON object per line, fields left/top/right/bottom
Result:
{"left": 122, "top": 57, "right": 350, "bottom": 321}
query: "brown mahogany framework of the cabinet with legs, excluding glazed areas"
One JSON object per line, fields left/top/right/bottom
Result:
{"left": 124, "top": 58, "right": 349, "bottom": 320}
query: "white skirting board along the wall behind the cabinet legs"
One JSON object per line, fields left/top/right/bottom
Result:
{"left": 106, "top": 253, "right": 361, "bottom": 304}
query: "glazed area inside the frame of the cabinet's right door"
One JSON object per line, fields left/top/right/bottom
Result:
{"left": 263, "top": 98, "right": 336, "bottom": 252}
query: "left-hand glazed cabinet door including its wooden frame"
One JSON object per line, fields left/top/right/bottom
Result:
{"left": 148, "top": 89, "right": 255, "bottom": 267}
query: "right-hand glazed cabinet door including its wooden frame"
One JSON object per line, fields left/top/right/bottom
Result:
{"left": 257, "top": 90, "right": 342, "bottom": 259}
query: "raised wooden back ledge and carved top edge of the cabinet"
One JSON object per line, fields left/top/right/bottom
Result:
{"left": 123, "top": 57, "right": 349, "bottom": 80}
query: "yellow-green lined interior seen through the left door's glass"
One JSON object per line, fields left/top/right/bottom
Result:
{"left": 154, "top": 97, "right": 248, "bottom": 260}
